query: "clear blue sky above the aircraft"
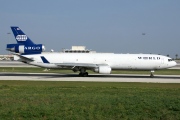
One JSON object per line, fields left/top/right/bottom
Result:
{"left": 0, "top": 0, "right": 180, "bottom": 58}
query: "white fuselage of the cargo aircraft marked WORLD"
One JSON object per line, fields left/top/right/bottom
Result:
{"left": 23, "top": 53, "right": 176, "bottom": 70}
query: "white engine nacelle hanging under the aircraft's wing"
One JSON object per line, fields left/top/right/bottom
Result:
{"left": 94, "top": 66, "right": 111, "bottom": 74}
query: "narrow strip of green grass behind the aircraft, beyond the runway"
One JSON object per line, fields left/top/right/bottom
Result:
{"left": 0, "top": 67, "right": 180, "bottom": 75}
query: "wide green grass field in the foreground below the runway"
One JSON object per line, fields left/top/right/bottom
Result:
{"left": 0, "top": 81, "right": 180, "bottom": 120}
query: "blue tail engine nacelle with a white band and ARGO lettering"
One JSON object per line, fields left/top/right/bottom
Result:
{"left": 6, "top": 44, "right": 45, "bottom": 54}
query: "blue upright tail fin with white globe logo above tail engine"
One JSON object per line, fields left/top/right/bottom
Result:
{"left": 11, "top": 26, "right": 34, "bottom": 45}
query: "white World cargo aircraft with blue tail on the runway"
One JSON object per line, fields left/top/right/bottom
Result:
{"left": 7, "top": 27, "right": 176, "bottom": 77}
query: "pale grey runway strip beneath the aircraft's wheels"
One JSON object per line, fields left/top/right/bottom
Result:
{"left": 0, "top": 73, "right": 180, "bottom": 83}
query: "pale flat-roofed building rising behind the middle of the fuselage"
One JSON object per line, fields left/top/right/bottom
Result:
{"left": 62, "top": 46, "right": 96, "bottom": 53}
